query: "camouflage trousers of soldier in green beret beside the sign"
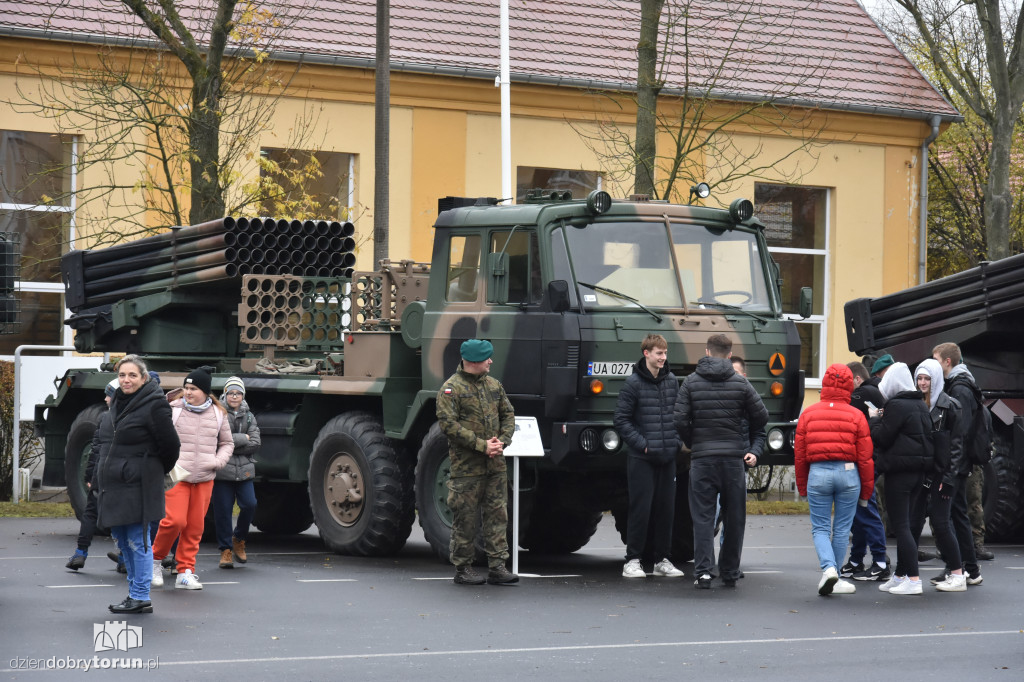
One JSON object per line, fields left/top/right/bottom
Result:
{"left": 447, "top": 471, "right": 509, "bottom": 568}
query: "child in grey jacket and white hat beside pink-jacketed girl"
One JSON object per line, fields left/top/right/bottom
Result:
{"left": 212, "top": 377, "right": 260, "bottom": 568}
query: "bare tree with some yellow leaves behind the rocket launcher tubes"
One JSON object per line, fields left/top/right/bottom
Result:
{"left": 10, "top": 0, "right": 314, "bottom": 246}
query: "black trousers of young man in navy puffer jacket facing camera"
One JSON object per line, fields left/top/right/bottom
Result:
{"left": 626, "top": 455, "right": 676, "bottom": 562}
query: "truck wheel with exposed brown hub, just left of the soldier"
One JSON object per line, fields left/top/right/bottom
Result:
{"left": 309, "top": 412, "right": 416, "bottom": 556}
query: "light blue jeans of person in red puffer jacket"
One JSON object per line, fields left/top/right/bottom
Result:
{"left": 807, "top": 462, "right": 860, "bottom": 570}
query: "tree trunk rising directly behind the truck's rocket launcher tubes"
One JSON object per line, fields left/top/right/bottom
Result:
{"left": 188, "top": 73, "right": 224, "bottom": 225}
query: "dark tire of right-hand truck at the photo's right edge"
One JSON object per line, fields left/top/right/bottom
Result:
{"left": 983, "top": 427, "right": 1024, "bottom": 543}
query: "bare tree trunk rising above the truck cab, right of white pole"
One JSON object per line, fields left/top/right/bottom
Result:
{"left": 633, "top": 0, "right": 665, "bottom": 198}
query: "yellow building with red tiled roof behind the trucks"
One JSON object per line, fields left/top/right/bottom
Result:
{"left": 0, "top": 0, "right": 958, "bottom": 388}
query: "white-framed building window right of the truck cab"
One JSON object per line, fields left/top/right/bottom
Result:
{"left": 754, "top": 182, "right": 829, "bottom": 386}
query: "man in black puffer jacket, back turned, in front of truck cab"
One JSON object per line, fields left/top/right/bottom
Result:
{"left": 674, "top": 334, "right": 768, "bottom": 590}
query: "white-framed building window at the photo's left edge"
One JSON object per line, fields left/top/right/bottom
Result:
{"left": 0, "top": 130, "right": 77, "bottom": 359}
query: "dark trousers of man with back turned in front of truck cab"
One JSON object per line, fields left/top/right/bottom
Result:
{"left": 690, "top": 457, "right": 746, "bottom": 581}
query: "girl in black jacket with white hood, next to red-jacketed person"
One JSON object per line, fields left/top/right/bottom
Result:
{"left": 869, "top": 363, "right": 935, "bottom": 595}
